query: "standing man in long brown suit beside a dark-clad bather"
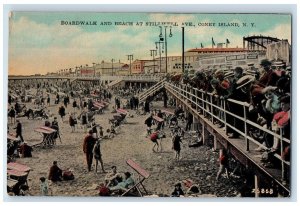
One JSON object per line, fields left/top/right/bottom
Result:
{"left": 83, "top": 130, "right": 96, "bottom": 172}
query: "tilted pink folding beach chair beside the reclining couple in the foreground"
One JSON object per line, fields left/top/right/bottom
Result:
{"left": 121, "top": 159, "right": 150, "bottom": 197}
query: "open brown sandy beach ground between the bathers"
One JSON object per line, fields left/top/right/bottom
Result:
{"left": 10, "top": 91, "right": 242, "bottom": 197}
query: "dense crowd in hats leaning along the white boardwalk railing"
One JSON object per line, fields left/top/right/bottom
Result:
{"left": 169, "top": 59, "right": 291, "bottom": 164}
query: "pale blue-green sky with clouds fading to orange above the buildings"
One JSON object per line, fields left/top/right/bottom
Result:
{"left": 9, "top": 12, "right": 291, "bottom": 75}
